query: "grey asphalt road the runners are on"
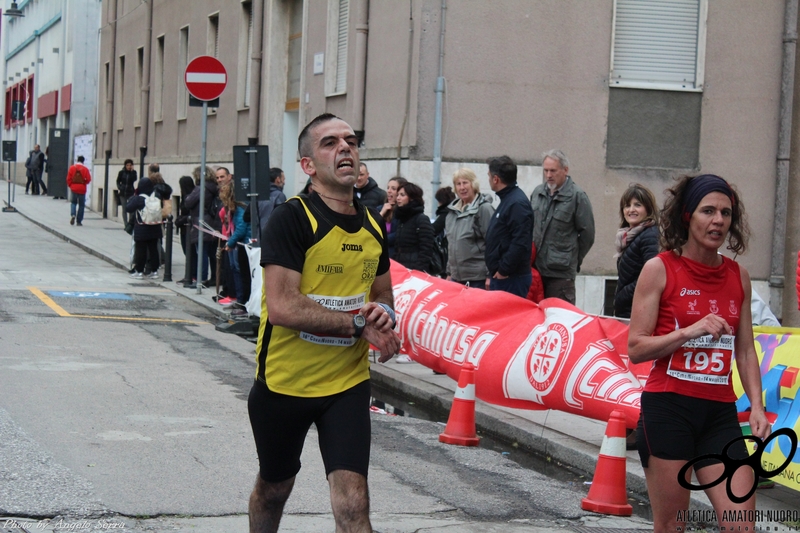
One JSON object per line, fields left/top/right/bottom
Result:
{"left": 0, "top": 214, "right": 648, "bottom": 532}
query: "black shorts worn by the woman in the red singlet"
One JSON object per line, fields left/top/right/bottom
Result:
{"left": 636, "top": 392, "right": 749, "bottom": 469}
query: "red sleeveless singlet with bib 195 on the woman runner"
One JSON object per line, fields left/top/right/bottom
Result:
{"left": 644, "top": 252, "right": 744, "bottom": 402}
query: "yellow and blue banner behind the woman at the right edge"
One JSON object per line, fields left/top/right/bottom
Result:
{"left": 733, "top": 326, "right": 800, "bottom": 490}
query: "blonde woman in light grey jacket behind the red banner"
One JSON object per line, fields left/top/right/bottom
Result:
{"left": 444, "top": 168, "right": 494, "bottom": 289}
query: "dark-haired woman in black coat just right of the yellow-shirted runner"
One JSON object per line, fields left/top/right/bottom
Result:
{"left": 392, "top": 183, "right": 434, "bottom": 272}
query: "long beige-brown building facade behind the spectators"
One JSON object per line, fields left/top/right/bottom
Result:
{"left": 95, "top": 0, "right": 800, "bottom": 325}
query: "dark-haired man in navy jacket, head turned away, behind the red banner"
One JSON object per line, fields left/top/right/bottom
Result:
{"left": 484, "top": 155, "right": 533, "bottom": 298}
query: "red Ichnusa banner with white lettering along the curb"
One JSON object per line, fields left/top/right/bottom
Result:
{"left": 392, "top": 262, "right": 642, "bottom": 428}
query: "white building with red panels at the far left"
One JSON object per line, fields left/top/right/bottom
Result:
{"left": 1, "top": 0, "right": 101, "bottom": 175}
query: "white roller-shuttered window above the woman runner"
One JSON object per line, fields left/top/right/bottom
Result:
{"left": 609, "top": 0, "right": 708, "bottom": 91}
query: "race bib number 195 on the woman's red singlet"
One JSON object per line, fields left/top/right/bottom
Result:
{"left": 667, "top": 335, "right": 735, "bottom": 385}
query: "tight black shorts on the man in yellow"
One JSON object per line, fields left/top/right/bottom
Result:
{"left": 247, "top": 380, "right": 371, "bottom": 483}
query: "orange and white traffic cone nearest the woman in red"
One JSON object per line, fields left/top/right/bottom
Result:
{"left": 581, "top": 411, "right": 633, "bottom": 516}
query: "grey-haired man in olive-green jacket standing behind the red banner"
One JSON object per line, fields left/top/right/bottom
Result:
{"left": 531, "top": 150, "right": 594, "bottom": 305}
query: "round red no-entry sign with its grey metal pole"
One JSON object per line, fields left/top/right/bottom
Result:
{"left": 183, "top": 56, "right": 228, "bottom": 294}
